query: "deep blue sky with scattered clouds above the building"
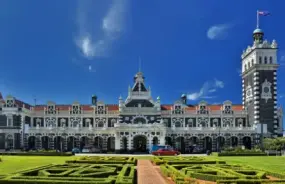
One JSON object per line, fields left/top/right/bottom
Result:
{"left": 0, "top": 0, "right": 285, "bottom": 109}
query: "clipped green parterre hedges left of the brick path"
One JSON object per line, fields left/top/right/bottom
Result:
{"left": 0, "top": 157, "right": 136, "bottom": 184}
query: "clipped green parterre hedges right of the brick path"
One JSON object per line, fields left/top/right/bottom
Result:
{"left": 153, "top": 157, "right": 285, "bottom": 184}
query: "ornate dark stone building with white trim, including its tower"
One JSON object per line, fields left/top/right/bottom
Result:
{"left": 0, "top": 28, "right": 283, "bottom": 152}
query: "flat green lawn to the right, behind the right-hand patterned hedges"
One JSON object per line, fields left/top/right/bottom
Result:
{"left": 213, "top": 156, "right": 285, "bottom": 174}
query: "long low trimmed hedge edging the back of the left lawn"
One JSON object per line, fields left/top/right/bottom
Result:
{"left": 0, "top": 152, "right": 72, "bottom": 156}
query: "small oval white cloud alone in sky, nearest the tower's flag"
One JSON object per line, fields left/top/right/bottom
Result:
{"left": 207, "top": 24, "right": 231, "bottom": 40}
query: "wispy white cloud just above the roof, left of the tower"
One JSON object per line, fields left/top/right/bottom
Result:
{"left": 187, "top": 79, "right": 225, "bottom": 101}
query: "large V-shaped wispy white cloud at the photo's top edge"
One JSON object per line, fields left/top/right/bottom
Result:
{"left": 75, "top": 0, "right": 129, "bottom": 59}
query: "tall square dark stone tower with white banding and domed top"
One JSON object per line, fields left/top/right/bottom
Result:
{"left": 241, "top": 28, "right": 279, "bottom": 137}
